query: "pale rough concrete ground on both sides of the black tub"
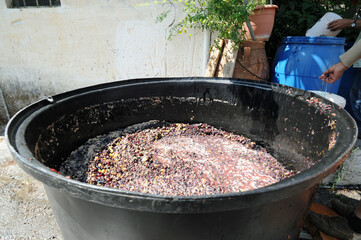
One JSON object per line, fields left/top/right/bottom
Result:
{"left": 0, "top": 136, "right": 361, "bottom": 240}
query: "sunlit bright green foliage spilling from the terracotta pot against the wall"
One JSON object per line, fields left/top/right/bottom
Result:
{"left": 157, "top": 0, "right": 266, "bottom": 48}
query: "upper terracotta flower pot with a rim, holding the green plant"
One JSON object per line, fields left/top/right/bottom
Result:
{"left": 244, "top": 4, "right": 278, "bottom": 41}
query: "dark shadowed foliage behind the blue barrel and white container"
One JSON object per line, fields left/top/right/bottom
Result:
{"left": 267, "top": 0, "right": 358, "bottom": 62}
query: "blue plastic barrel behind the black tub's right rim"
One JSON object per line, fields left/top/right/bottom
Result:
{"left": 271, "top": 37, "right": 345, "bottom": 94}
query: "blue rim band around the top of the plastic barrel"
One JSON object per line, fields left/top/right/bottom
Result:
{"left": 281, "top": 36, "right": 346, "bottom": 45}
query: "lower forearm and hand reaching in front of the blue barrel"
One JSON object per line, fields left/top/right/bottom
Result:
{"left": 319, "top": 40, "right": 361, "bottom": 83}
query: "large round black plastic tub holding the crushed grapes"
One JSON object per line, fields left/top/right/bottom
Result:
{"left": 6, "top": 78, "right": 357, "bottom": 240}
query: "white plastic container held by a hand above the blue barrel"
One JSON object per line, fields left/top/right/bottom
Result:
{"left": 306, "top": 12, "right": 342, "bottom": 37}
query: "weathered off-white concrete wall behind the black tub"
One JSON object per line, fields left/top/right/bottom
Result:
{"left": 0, "top": 0, "right": 205, "bottom": 125}
